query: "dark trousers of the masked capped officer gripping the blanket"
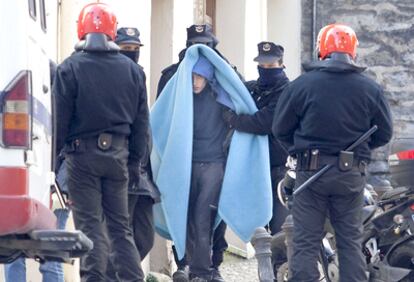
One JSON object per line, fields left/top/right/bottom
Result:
{"left": 269, "top": 166, "right": 289, "bottom": 235}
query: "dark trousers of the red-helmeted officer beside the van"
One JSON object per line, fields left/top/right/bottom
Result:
{"left": 66, "top": 145, "right": 144, "bottom": 282}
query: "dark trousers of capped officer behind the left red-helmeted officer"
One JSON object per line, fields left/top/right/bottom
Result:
{"left": 106, "top": 194, "right": 154, "bottom": 282}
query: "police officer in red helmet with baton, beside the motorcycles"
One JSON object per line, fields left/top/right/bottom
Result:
{"left": 273, "top": 24, "right": 392, "bottom": 282}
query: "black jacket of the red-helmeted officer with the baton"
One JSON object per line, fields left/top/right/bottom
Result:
{"left": 272, "top": 60, "right": 392, "bottom": 159}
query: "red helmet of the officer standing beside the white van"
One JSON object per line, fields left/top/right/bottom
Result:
{"left": 78, "top": 3, "right": 117, "bottom": 40}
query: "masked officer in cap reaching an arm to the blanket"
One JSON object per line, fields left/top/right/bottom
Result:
{"left": 224, "top": 42, "right": 289, "bottom": 235}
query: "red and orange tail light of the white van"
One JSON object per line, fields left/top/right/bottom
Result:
{"left": 0, "top": 71, "right": 32, "bottom": 149}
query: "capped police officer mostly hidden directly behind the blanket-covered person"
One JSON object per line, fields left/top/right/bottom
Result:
{"left": 157, "top": 24, "right": 228, "bottom": 282}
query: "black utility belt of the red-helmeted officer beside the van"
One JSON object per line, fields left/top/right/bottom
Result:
{"left": 65, "top": 133, "right": 128, "bottom": 153}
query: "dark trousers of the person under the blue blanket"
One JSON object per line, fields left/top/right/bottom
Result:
{"left": 186, "top": 163, "right": 224, "bottom": 280}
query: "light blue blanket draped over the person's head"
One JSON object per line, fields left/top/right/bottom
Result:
{"left": 150, "top": 44, "right": 272, "bottom": 258}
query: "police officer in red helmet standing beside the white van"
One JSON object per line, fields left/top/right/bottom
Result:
{"left": 54, "top": 3, "right": 148, "bottom": 281}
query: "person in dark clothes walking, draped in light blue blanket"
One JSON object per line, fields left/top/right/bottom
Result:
{"left": 150, "top": 44, "right": 272, "bottom": 281}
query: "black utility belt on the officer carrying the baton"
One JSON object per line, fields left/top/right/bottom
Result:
{"left": 296, "top": 149, "right": 367, "bottom": 174}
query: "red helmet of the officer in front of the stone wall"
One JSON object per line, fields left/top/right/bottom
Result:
{"left": 317, "top": 24, "right": 358, "bottom": 60}
